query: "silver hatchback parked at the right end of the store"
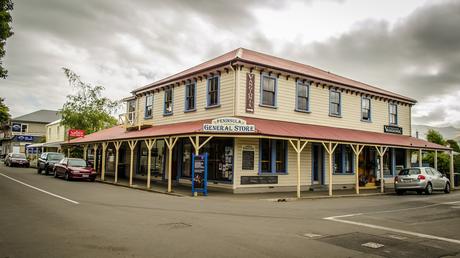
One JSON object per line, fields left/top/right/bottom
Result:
{"left": 395, "top": 167, "right": 450, "bottom": 194}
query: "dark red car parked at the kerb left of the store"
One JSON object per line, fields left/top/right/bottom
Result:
{"left": 54, "top": 158, "right": 96, "bottom": 181}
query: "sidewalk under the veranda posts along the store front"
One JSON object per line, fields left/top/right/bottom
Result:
{"left": 96, "top": 175, "right": 394, "bottom": 202}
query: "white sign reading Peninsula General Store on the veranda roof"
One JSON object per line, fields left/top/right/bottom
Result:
{"left": 203, "top": 117, "right": 256, "bottom": 133}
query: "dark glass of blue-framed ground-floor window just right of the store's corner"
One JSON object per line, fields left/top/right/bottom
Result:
{"left": 259, "top": 139, "right": 287, "bottom": 173}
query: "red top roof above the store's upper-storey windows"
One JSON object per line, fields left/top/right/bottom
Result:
{"left": 133, "top": 48, "right": 417, "bottom": 103}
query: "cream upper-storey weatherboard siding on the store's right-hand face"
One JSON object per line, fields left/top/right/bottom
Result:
{"left": 236, "top": 68, "right": 411, "bottom": 135}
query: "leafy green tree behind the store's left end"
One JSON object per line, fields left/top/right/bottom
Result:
{"left": 60, "top": 68, "right": 118, "bottom": 134}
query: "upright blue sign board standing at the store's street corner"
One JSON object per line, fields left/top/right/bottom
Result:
{"left": 192, "top": 153, "right": 208, "bottom": 196}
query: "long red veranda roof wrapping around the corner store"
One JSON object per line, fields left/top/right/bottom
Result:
{"left": 63, "top": 117, "right": 451, "bottom": 150}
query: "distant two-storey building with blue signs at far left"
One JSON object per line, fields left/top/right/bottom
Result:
{"left": 1, "top": 110, "right": 60, "bottom": 154}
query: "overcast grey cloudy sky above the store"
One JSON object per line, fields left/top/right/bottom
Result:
{"left": 0, "top": 0, "right": 460, "bottom": 127}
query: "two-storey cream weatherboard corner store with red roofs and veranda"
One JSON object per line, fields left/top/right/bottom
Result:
{"left": 64, "top": 48, "right": 453, "bottom": 196}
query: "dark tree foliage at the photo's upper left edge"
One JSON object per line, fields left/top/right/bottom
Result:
{"left": 0, "top": 0, "right": 13, "bottom": 79}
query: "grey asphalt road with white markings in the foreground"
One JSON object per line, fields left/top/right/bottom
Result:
{"left": 0, "top": 165, "right": 460, "bottom": 257}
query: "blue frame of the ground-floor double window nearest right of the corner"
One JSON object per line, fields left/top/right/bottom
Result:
{"left": 259, "top": 138, "right": 289, "bottom": 175}
